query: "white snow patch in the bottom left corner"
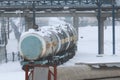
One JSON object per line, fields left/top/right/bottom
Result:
{"left": 0, "top": 62, "right": 25, "bottom": 80}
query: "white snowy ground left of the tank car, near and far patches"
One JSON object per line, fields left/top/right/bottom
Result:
{"left": 0, "top": 32, "right": 25, "bottom": 80}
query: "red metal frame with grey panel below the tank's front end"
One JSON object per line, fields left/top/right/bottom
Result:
{"left": 25, "top": 64, "right": 57, "bottom": 80}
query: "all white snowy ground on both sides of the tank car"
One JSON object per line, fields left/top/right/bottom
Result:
{"left": 0, "top": 26, "right": 120, "bottom": 80}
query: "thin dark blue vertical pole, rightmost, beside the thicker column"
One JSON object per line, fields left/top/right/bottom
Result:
{"left": 112, "top": 2, "right": 115, "bottom": 55}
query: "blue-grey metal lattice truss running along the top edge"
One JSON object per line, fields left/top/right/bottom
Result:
{"left": 0, "top": 0, "right": 119, "bottom": 11}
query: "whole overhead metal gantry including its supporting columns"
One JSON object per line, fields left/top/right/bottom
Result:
{"left": 0, "top": 0, "right": 120, "bottom": 63}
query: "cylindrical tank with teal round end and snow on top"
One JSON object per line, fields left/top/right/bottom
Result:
{"left": 19, "top": 25, "right": 77, "bottom": 61}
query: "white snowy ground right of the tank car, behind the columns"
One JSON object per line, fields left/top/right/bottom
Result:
{"left": 63, "top": 26, "right": 120, "bottom": 66}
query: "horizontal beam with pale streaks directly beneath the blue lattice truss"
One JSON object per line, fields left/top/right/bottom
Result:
{"left": 0, "top": 11, "right": 117, "bottom": 17}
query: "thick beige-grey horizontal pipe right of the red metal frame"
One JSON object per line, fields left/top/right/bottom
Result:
{"left": 57, "top": 65, "right": 120, "bottom": 80}
